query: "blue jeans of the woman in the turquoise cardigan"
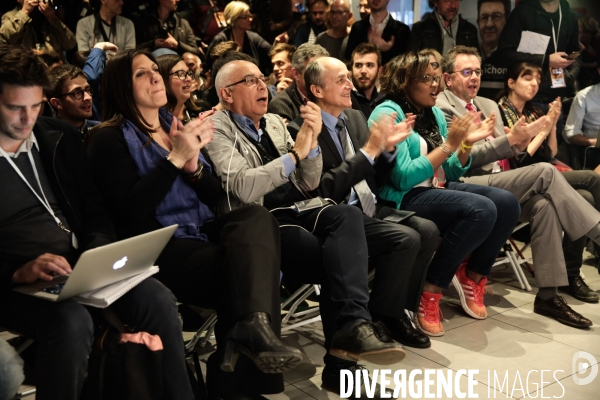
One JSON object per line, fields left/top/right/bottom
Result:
{"left": 402, "top": 182, "right": 521, "bottom": 289}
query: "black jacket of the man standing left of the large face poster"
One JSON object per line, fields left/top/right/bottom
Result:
{"left": 408, "top": 12, "right": 479, "bottom": 55}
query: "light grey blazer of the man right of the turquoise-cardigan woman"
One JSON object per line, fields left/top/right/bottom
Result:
{"left": 435, "top": 89, "right": 521, "bottom": 177}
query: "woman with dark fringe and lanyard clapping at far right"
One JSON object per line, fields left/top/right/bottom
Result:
{"left": 498, "top": 63, "right": 600, "bottom": 303}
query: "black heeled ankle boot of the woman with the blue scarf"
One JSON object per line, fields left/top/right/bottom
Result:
{"left": 221, "top": 312, "right": 302, "bottom": 374}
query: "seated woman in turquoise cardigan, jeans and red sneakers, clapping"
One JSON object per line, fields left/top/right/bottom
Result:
{"left": 369, "top": 50, "right": 520, "bottom": 336}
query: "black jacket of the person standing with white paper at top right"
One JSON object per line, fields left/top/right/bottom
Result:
{"left": 497, "top": 0, "right": 580, "bottom": 103}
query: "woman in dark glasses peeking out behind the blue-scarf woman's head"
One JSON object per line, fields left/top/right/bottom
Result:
{"left": 156, "top": 54, "right": 201, "bottom": 124}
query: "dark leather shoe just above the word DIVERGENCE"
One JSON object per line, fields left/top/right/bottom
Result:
{"left": 329, "top": 320, "right": 406, "bottom": 365}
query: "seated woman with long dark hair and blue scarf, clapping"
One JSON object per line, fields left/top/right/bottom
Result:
{"left": 88, "top": 51, "right": 301, "bottom": 399}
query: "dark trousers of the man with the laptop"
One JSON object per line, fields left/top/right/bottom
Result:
{"left": 0, "top": 278, "right": 194, "bottom": 400}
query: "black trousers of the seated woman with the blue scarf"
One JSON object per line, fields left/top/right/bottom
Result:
{"left": 157, "top": 205, "right": 283, "bottom": 396}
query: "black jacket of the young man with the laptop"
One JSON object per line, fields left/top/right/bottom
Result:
{"left": 0, "top": 117, "right": 115, "bottom": 292}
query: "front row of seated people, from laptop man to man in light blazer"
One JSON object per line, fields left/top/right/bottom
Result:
{"left": 0, "top": 39, "right": 600, "bottom": 399}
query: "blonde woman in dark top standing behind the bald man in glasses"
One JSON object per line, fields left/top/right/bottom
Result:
{"left": 205, "top": 1, "right": 272, "bottom": 75}
